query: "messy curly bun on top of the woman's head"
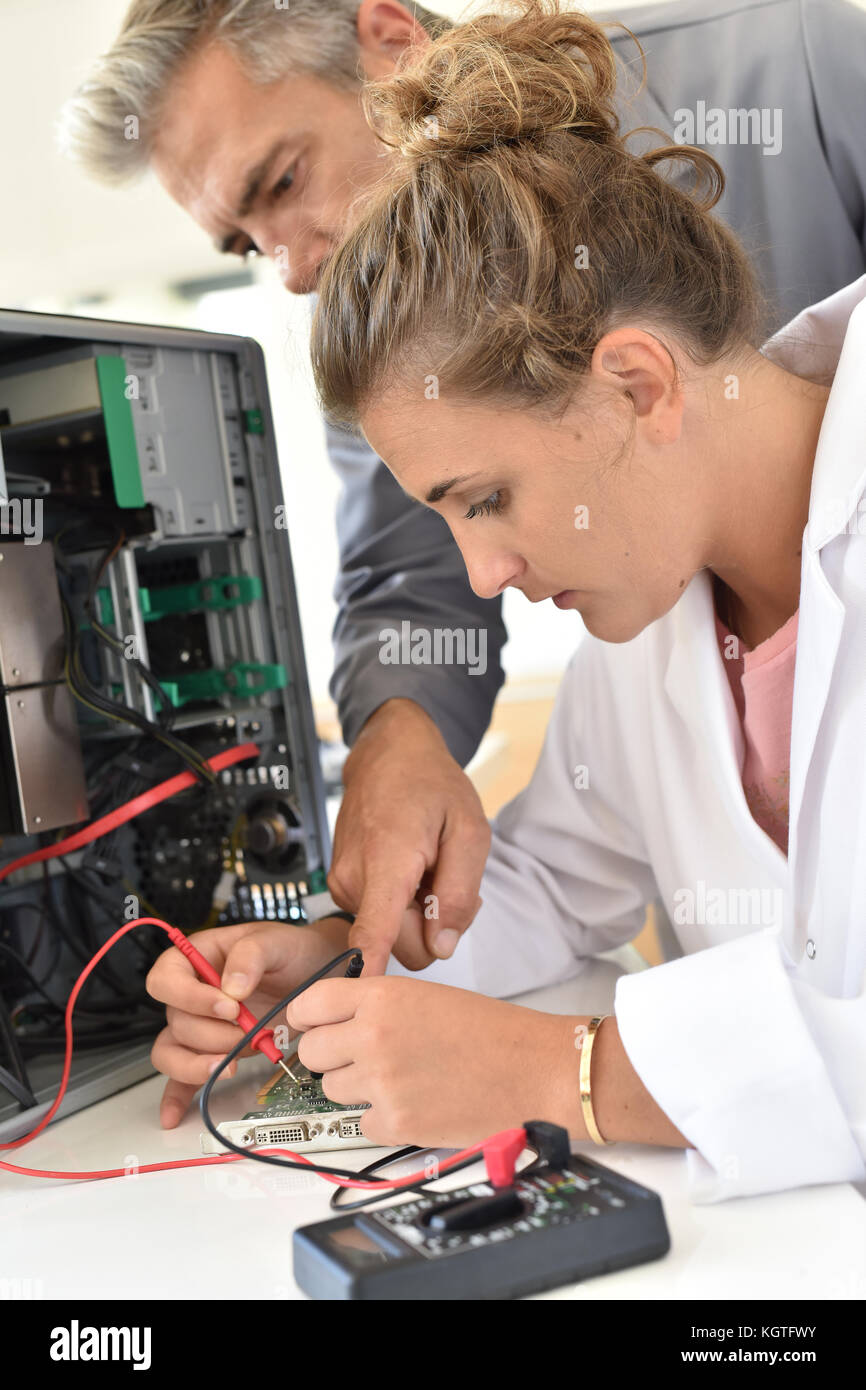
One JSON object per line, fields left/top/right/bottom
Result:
{"left": 364, "top": 0, "right": 620, "bottom": 161}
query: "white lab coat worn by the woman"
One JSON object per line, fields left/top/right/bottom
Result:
{"left": 397, "top": 277, "right": 866, "bottom": 1201}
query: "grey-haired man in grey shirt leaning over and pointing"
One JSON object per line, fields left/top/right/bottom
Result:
{"left": 65, "top": 0, "right": 866, "bottom": 973}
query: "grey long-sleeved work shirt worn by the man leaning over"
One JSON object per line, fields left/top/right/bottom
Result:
{"left": 325, "top": 0, "right": 866, "bottom": 776}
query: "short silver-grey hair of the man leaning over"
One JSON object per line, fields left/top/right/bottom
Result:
{"left": 58, "top": 0, "right": 450, "bottom": 183}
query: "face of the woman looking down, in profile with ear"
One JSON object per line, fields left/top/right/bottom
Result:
{"left": 361, "top": 335, "right": 705, "bottom": 642}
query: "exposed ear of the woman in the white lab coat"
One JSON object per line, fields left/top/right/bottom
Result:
{"left": 591, "top": 328, "right": 683, "bottom": 443}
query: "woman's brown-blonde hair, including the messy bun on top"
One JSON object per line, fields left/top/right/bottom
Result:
{"left": 311, "top": 0, "right": 763, "bottom": 427}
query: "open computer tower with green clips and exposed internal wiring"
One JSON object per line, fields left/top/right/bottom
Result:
{"left": 0, "top": 311, "right": 328, "bottom": 1140}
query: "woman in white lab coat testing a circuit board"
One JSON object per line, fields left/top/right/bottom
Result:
{"left": 145, "top": 0, "right": 866, "bottom": 1200}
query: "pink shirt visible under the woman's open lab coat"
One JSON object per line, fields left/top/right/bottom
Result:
{"left": 716, "top": 613, "right": 799, "bottom": 853}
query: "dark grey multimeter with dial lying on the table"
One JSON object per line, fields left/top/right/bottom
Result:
{"left": 293, "top": 1154, "right": 670, "bottom": 1300}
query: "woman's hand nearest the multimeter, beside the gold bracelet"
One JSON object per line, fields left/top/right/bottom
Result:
{"left": 286, "top": 976, "right": 585, "bottom": 1148}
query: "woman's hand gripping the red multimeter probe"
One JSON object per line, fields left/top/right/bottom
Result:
{"left": 146, "top": 917, "right": 349, "bottom": 1129}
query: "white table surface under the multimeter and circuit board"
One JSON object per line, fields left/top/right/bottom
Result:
{"left": 0, "top": 956, "right": 866, "bottom": 1300}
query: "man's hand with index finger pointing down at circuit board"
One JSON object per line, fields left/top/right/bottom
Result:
{"left": 328, "top": 699, "right": 491, "bottom": 979}
